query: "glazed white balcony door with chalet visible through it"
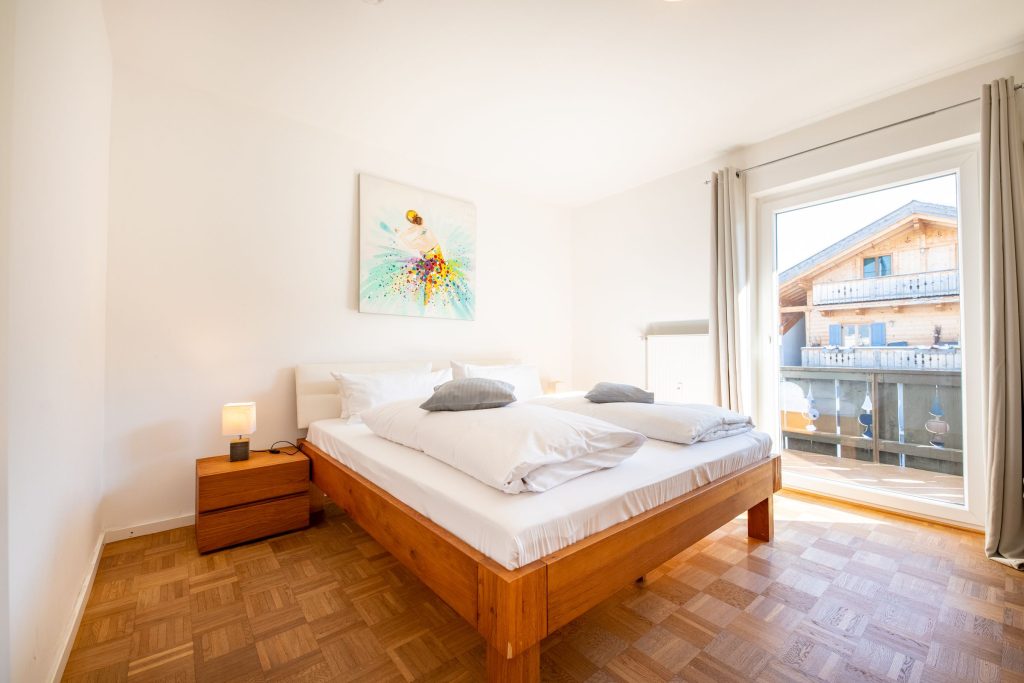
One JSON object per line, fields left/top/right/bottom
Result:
{"left": 759, "top": 145, "right": 983, "bottom": 525}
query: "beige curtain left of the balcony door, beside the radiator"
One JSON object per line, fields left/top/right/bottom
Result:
{"left": 709, "top": 168, "right": 746, "bottom": 411}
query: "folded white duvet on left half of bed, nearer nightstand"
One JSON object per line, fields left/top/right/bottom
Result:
{"left": 360, "top": 399, "right": 646, "bottom": 494}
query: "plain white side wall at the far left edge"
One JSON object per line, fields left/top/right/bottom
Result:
{"left": 4, "top": 0, "right": 112, "bottom": 681}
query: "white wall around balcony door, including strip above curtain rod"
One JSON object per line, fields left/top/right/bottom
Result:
{"left": 572, "top": 52, "right": 1024, "bottom": 387}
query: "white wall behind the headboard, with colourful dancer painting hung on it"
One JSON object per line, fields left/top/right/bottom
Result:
{"left": 103, "top": 63, "right": 571, "bottom": 528}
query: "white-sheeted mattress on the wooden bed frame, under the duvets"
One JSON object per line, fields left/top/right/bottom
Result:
{"left": 306, "top": 420, "right": 771, "bottom": 569}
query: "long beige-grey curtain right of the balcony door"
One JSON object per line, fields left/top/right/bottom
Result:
{"left": 981, "top": 79, "right": 1024, "bottom": 569}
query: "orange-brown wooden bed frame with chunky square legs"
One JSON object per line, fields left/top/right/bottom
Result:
{"left": 299, "top": 439, "right": 781, "bottom": 682}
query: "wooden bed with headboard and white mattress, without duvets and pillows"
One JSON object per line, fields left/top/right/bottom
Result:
{"left": 296, "top": 364, "right": 780, "bottom": 681}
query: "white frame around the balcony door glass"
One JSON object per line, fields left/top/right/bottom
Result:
{"left": 750, "top": 141, "right": 986, "bottom": 529}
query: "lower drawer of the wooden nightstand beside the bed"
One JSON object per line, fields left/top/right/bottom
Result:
{"left": 196, "top": 490, "right": 309, "bottom": 553}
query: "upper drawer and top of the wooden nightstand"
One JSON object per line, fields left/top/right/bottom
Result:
{"left": 196, "top": 454, "right": 309, "bottom": 512}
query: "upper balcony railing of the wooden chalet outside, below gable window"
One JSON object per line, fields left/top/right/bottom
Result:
{"left": 811, "top": 270, "right": 959, "bottom": 306}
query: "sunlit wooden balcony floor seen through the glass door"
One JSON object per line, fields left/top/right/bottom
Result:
{"left": 782, "top": 451, "right": 964, "bottom": 505}
